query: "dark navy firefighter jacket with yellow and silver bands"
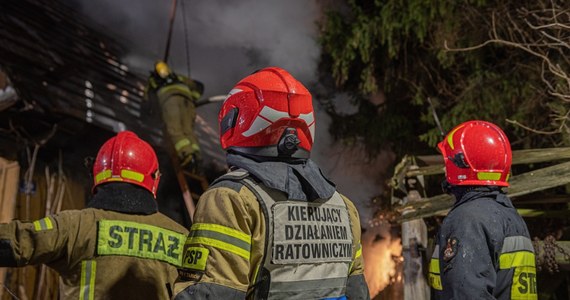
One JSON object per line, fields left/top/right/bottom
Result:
{"left": 429, "top": 188, "right": 537, "bottom": 300}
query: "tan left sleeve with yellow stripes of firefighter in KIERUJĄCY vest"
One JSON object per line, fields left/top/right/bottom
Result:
{"left": 171, "top": 181, "right": 258, "bottom": 299}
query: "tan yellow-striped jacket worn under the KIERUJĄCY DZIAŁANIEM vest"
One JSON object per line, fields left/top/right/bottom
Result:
{"left": 175, "top": 170, "right": 369, "bottom": 299}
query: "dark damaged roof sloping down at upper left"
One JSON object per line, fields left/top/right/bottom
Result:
{"left": 0, "top": 0, "right": 162, "bottom": 144}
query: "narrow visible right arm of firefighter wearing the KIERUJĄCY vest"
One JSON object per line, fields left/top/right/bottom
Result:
{"left": 342, "top": 196, "right": 370, "bottom": 299}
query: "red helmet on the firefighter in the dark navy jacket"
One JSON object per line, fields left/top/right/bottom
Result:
{"left": 438, "top": 121, "right": 512, "bottom": 186}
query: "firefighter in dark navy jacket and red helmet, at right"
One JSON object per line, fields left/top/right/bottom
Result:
{"left": 429, "top": 121, "right": 537, "bottom": 299}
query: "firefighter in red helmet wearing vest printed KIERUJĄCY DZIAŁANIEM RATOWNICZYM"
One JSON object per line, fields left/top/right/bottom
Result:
{"left": 175, "top": 67, "right": 370, "bottom": 299}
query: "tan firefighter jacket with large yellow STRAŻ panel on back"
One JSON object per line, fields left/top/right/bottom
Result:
{"left": 0, "top": 208, "right": 188, "bottom": 300}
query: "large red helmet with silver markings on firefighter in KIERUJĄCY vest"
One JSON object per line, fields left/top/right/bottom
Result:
{"left": 218, "top": 67, "right": 315, "bottom": 158}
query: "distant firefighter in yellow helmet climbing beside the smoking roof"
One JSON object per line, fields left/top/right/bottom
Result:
{"left": 145, "top": 61, "right": 204, "bottom": 172}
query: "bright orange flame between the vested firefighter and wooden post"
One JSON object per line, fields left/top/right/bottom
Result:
{"left": 362, "top": 223, "right": 403, "bottom": 299}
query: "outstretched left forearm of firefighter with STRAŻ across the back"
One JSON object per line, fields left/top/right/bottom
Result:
{"left": 0, "top": 215, "right": 73, "bottom": 267}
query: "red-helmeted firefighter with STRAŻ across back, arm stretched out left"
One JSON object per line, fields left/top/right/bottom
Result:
{"left": 0, "top": 131, "right": 188, "bottom": 300}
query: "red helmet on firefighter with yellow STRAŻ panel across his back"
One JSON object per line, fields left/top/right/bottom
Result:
{"left": 92, "top": 131, "right": 160, "bottom": 198}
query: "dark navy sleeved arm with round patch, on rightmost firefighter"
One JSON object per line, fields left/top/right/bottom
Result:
{"left": 439, "top": 211, "right": 497, "bottom": 299}
